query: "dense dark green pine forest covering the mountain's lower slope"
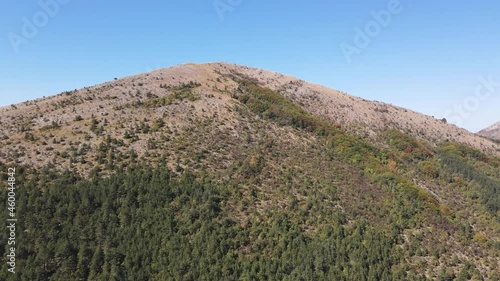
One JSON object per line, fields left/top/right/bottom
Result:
{"left": 1, "top": 163, "right": 404, "bottom": 280}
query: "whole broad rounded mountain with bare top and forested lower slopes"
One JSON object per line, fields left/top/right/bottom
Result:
{"left": 0, "top": 63, "right": 500, "bottom": 280}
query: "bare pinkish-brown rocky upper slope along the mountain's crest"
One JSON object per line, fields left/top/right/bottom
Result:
{"left": 0, "top": 63, "right": 500, "bottom": 171}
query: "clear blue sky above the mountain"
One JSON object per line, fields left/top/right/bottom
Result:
{"left": 0, "top": 0, "right": 500, "bottom": 131}
